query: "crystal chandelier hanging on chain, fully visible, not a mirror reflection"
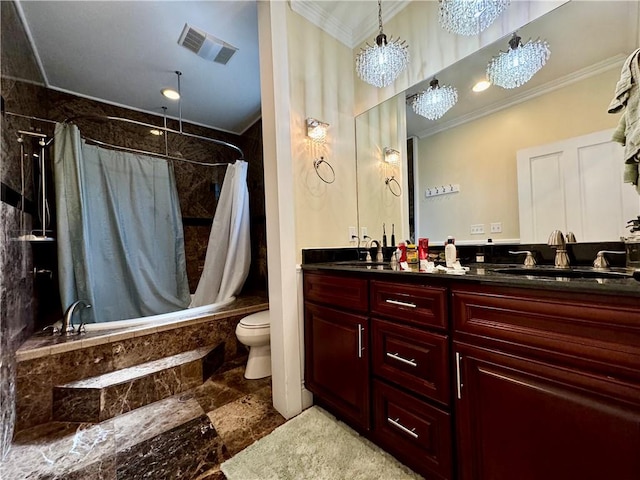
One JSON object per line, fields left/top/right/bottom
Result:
{"left": 356, "top": 0, "right": 409, "bottom": 88}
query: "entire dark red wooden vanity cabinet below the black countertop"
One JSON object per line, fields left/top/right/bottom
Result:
{"left": 304, "top": 265, "right": 640, "bottom": 480}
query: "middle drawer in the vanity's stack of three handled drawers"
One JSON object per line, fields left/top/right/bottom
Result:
{"left": 371, "top": 319, "right": 450, "bottom": 405}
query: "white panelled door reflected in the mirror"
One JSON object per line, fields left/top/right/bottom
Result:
{"left": 517, "top": 130, "right": 640, "bottom": 243}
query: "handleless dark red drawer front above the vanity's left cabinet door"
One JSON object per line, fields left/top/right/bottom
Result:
{"left": 304, "top": 272, "right": 369, "bottom": 312}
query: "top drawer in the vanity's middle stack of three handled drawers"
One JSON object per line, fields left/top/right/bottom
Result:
{"left": 371, "top": 280, "right": 447, "bottom": 329}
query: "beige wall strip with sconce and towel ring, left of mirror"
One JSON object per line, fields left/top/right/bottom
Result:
{"left": 287, "top": 8, "right": 357, "bottom": 261}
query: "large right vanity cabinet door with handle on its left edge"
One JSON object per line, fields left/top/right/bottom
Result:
{"left": 454, "top": 342, "right": 640, "bottom": 480}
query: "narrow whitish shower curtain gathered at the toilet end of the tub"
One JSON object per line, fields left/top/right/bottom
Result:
{"left": 190, "top": 160, "right": 251, "bottom": 307}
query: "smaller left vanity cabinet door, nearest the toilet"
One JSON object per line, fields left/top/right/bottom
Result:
{"left": 305, "top": 302, "right": 370, "bottom": 430}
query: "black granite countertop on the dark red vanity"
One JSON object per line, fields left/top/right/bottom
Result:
{"left": 302, "top": 261, "right": 640, "bottom": 296}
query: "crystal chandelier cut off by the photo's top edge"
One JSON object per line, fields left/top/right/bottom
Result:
{"left": 440, "top": 0, "right": 510, "bottom": 35}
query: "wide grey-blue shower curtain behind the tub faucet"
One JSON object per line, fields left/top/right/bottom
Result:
{"left": 54, "top": 124, "right": 190, "bottom": 322}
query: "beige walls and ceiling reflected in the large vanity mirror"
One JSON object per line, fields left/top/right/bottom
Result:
{"left": 356, "top": 1, "right": 638, "bottom": 244}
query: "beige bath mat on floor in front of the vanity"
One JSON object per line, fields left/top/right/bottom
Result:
{"left": 221, "top": 406, "right": 422, "bottom": 480}
